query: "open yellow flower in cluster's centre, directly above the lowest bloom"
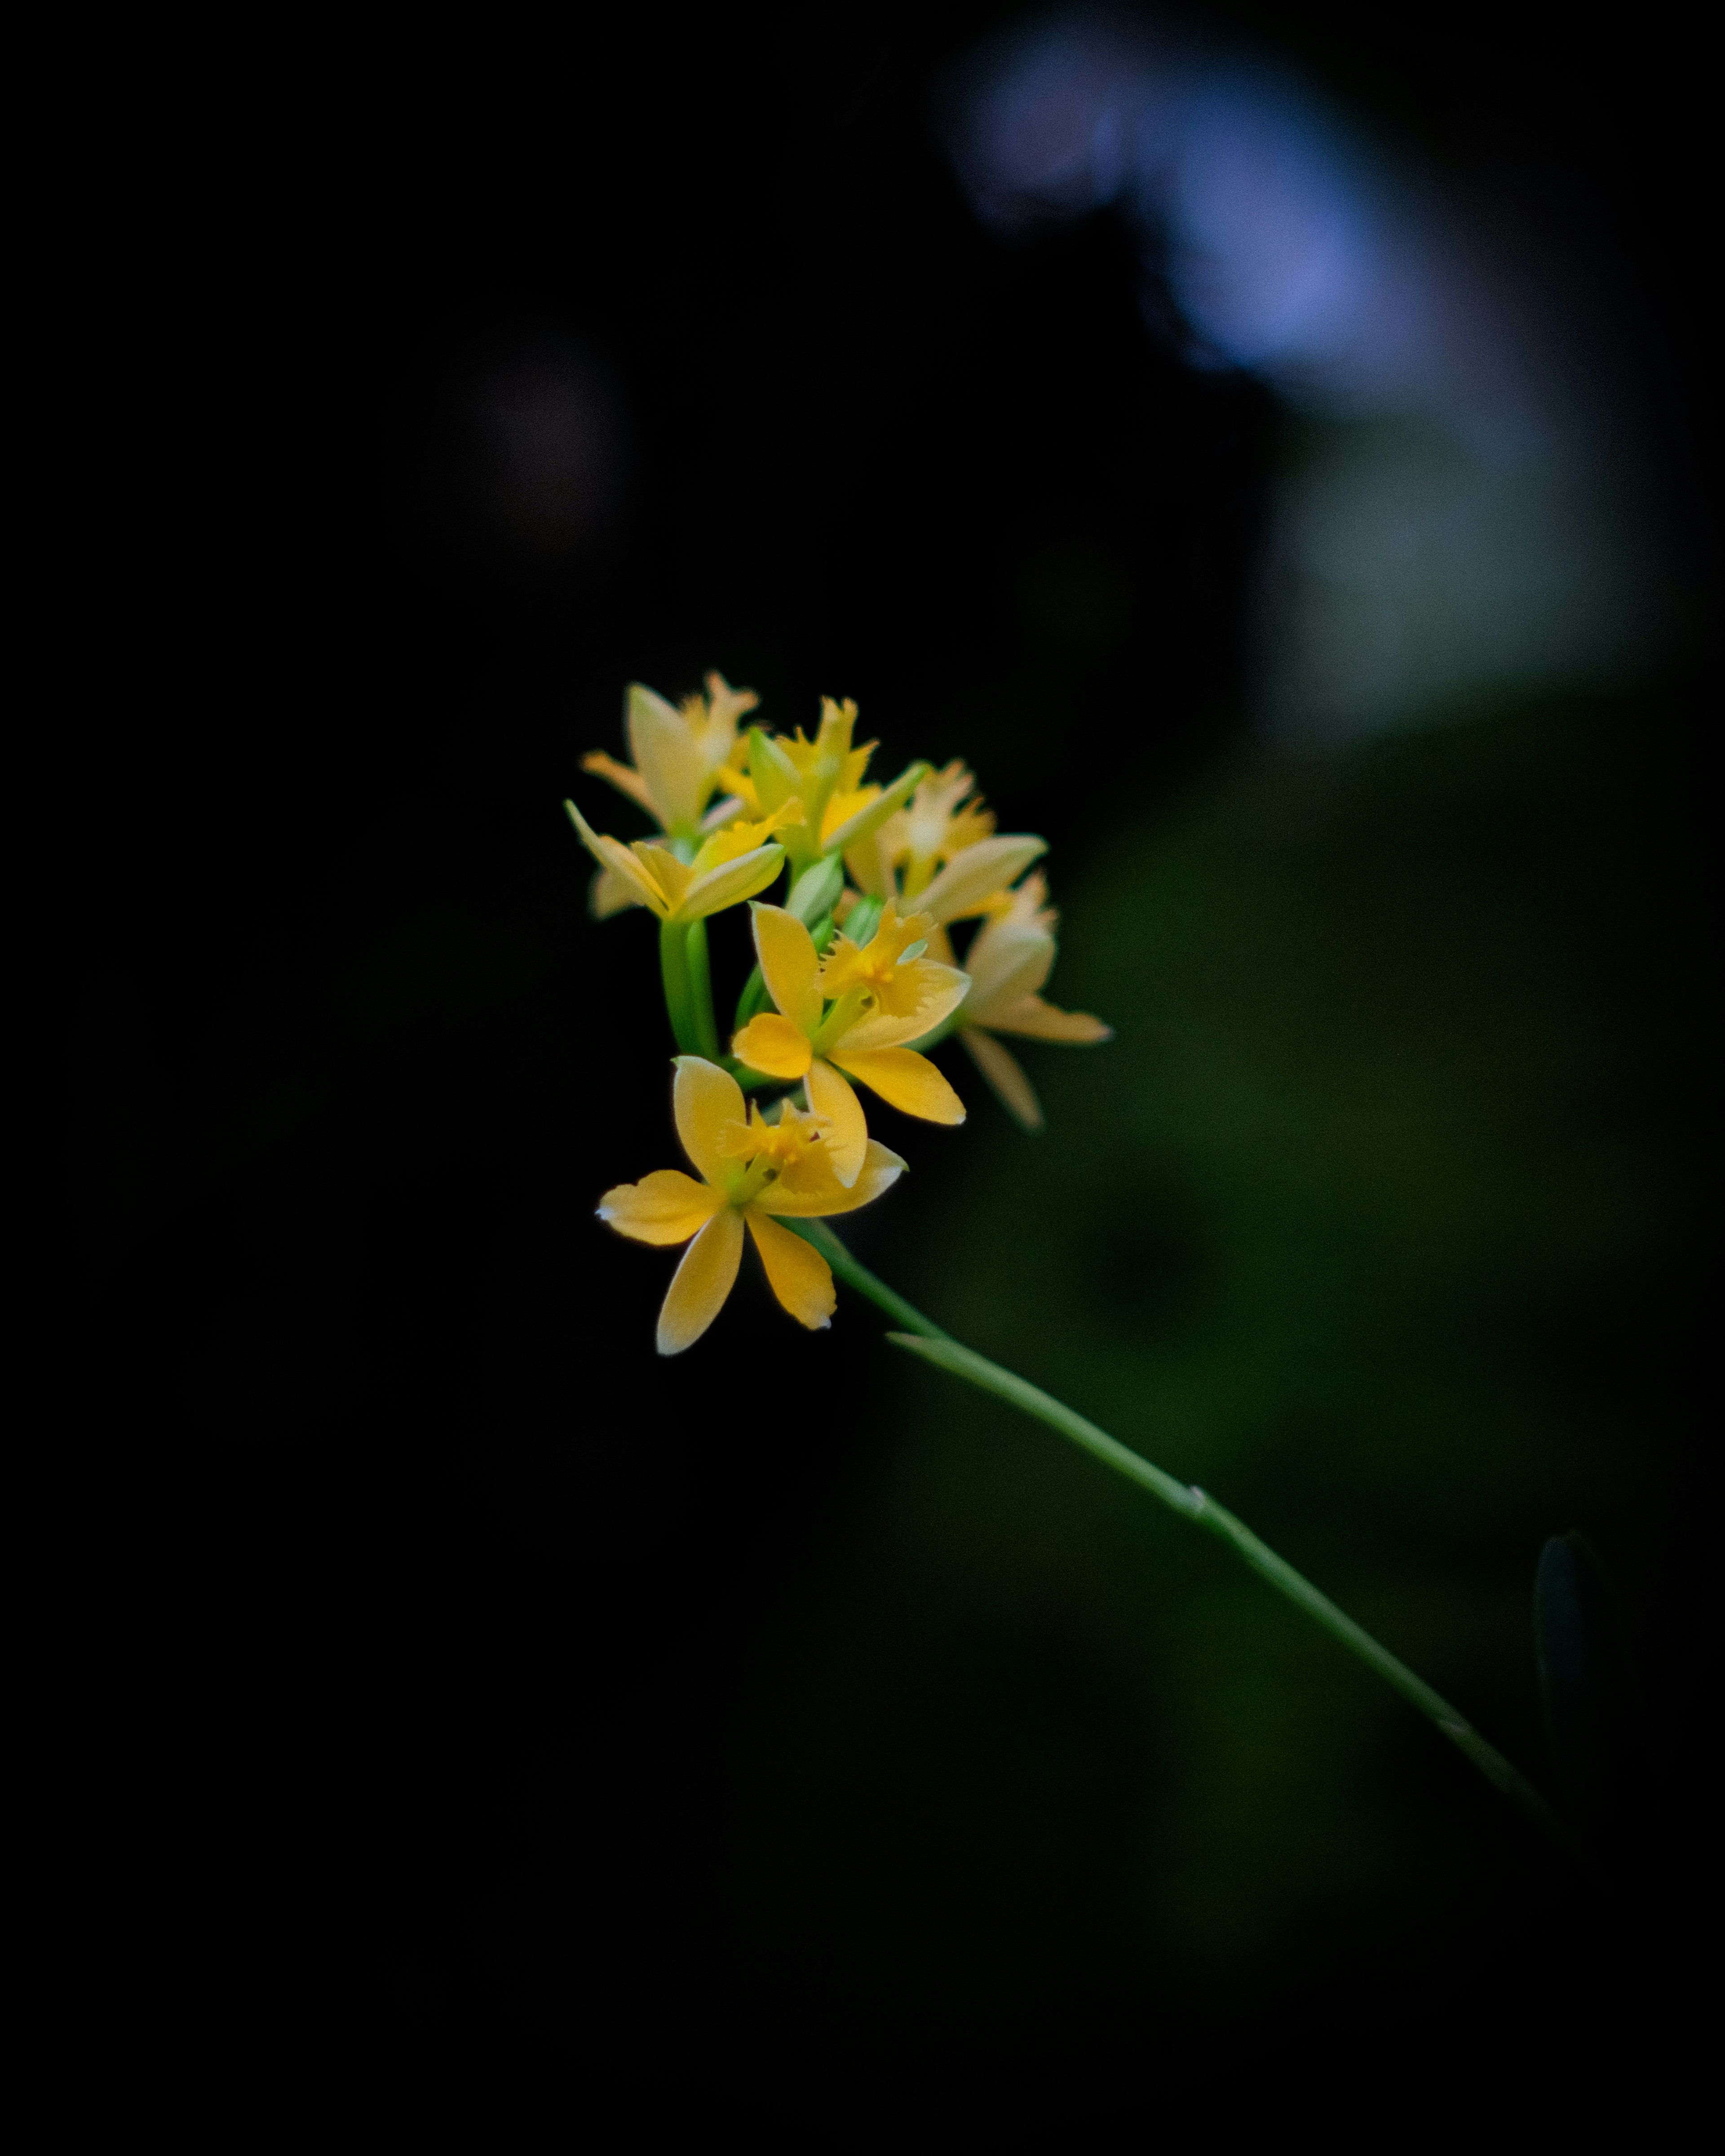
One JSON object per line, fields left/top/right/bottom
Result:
{"left": 731, "top": 899, "right": 970, "bottom": 1186}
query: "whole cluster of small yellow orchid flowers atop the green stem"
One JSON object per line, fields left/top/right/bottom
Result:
{"left": 565, "top": 673, "right": 1108, "bottom": 1354}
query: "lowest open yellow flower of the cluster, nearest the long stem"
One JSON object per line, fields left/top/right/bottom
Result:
{"left": 599, "top": 1056, "right": 903, "bottom": 1354}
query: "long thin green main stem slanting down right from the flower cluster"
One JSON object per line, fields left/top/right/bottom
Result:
{"left": 785, "top": 1220, "right": 1580, "bottom": 1856}
